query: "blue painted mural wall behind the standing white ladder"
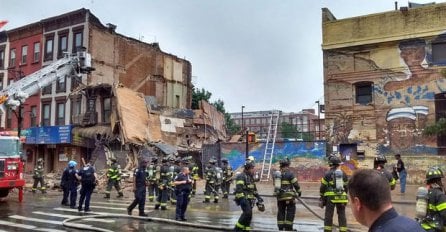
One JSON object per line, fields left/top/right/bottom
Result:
{"left": 221, "top": 141, "right": 334, "bottom": 181}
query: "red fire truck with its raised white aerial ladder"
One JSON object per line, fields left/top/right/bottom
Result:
{"left": 0, "top": 51, "right": 94, "bottom": 202}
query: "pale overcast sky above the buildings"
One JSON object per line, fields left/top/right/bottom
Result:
{"left": 0, "top": 0, "right": 444, "bottom": 112}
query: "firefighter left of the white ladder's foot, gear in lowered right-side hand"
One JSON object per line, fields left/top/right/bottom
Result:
{"left": 234, "top": 161, "right": 265, "bottom": 231}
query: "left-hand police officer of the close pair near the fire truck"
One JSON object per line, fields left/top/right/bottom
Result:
{"left": 60, "top": 160, "right": 78, "bottom": 209}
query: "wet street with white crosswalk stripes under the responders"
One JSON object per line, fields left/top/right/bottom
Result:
{"left": 0, "top": 183, "right": 415, "bottom": 232}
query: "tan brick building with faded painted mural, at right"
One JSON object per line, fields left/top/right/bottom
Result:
{"left": 322, "top": 4, "right": 446, "bottom": 182}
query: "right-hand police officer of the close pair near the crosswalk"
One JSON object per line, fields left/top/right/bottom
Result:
{"left": 75, "top": 162, "right": 98, "bottom": 212}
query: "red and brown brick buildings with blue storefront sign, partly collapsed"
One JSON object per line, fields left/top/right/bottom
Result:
{"left": 0, "top": 9, "right": 192, "bottom": 172}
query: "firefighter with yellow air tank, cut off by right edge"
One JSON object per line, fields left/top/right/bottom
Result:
{"left": 417, "top": 167, "right": 446, "bottom": 232}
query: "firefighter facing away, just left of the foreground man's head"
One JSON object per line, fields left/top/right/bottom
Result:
{"left": 320, "top": 155, "right": 348, "bottom": 232}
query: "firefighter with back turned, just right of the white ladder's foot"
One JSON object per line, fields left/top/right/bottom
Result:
{"left": 274, "top": 157, "right": 302, "bottom": 231}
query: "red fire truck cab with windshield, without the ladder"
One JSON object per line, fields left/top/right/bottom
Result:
{"left": 0, "top": 132, "right": 25, "bottom": 202}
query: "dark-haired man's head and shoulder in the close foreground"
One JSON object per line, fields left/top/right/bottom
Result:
{"left": 347, "top": 169, "right": 424, "bottom": 232}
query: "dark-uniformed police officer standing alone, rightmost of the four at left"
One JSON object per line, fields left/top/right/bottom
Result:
{"left": 173, "top": 166, "right": 192, "bottom": 221}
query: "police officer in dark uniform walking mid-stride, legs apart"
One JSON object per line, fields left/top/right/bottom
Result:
{"left": 127, "top": 159, "right": 148, "bottom": 217}
